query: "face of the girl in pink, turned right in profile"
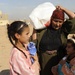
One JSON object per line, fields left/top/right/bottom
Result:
{"left": 18, "top": 27, "right": 30, "bottom": 44}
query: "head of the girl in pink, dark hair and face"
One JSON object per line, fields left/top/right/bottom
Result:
{"left": 7, "top": 21, "right": 29, "bottom": 45}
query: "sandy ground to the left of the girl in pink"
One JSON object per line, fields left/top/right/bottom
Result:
{"left": 0, "top": 25, "right": 32, "bottom": 75}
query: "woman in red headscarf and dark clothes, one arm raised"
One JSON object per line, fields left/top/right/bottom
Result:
{"left": 33, "top": 6, "right": 75, "bottom": 75}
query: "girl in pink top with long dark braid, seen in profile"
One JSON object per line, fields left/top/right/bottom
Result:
{"left": 7, "top": 21, "right": 39, "bottom": 75}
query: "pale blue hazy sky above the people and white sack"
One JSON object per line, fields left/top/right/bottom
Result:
{"left": 0, "top": 0, "right": 75, "bottom": 20}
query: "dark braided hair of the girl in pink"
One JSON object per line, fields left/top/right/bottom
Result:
{"left": 7, "top": 21, "right": 28, "bottom": 57}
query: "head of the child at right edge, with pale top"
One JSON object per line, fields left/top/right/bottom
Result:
{"left": 66, "top": 34, "right": 75, "bottom": 55}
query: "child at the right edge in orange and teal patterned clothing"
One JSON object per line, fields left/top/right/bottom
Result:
{"left": 52, "top": 34, "right": 75, "bottom": 75}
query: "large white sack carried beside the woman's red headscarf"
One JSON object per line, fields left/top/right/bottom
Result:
{"left": 29, "top": 2, "right": 55, "bottom": 29}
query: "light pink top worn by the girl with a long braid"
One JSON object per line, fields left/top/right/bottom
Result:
{"left": 10, "top": 48, "right": 35, "bottom": 75}
